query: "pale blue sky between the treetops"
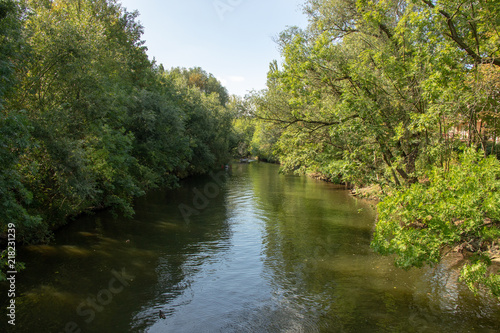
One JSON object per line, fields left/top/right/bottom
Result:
{"left": 119, "top": 0, "right": 307, "bottom": 97}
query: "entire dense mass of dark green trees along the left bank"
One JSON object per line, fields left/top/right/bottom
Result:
{"left": 0, "top": 0, "right": 236, "bottom": 278}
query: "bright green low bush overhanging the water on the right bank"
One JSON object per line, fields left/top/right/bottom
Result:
{"left": 372, "top": 150, "right": 500, "bottom": 296}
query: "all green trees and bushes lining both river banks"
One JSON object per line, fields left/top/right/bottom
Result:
{"left": 0, "top": 0, "right": 500, "bottom": 296}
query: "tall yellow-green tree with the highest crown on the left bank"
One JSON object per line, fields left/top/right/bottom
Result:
{"left": 13, "top": 0, "right": 149, "bottom": 223}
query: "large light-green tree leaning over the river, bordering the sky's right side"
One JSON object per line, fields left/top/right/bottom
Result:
{"left": 260, "top": 1, "right": 432, "bottom": 184}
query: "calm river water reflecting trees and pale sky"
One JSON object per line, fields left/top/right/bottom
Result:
{"left": 0, "top": 163, "right": 500, "bottom": 333}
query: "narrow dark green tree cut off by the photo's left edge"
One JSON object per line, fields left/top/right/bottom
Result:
{"left": 0, "top": 0, "right": 47, "bottom": 280}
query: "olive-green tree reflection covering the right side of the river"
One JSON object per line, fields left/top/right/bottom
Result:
{"left": 249, "top": 165, "right": 499, "bottom": 332}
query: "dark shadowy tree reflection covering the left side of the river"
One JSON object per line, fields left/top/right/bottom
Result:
{"left": 0, "top": 177, "right": 231, "bottom": 333}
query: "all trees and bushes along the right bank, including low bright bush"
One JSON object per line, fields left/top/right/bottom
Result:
{"left": 239, "top": 0, "right": 500, "bottom": 296}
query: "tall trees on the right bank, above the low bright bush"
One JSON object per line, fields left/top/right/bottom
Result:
{"left": 258, "top": 0, "right": 498, "bottom": 186}
